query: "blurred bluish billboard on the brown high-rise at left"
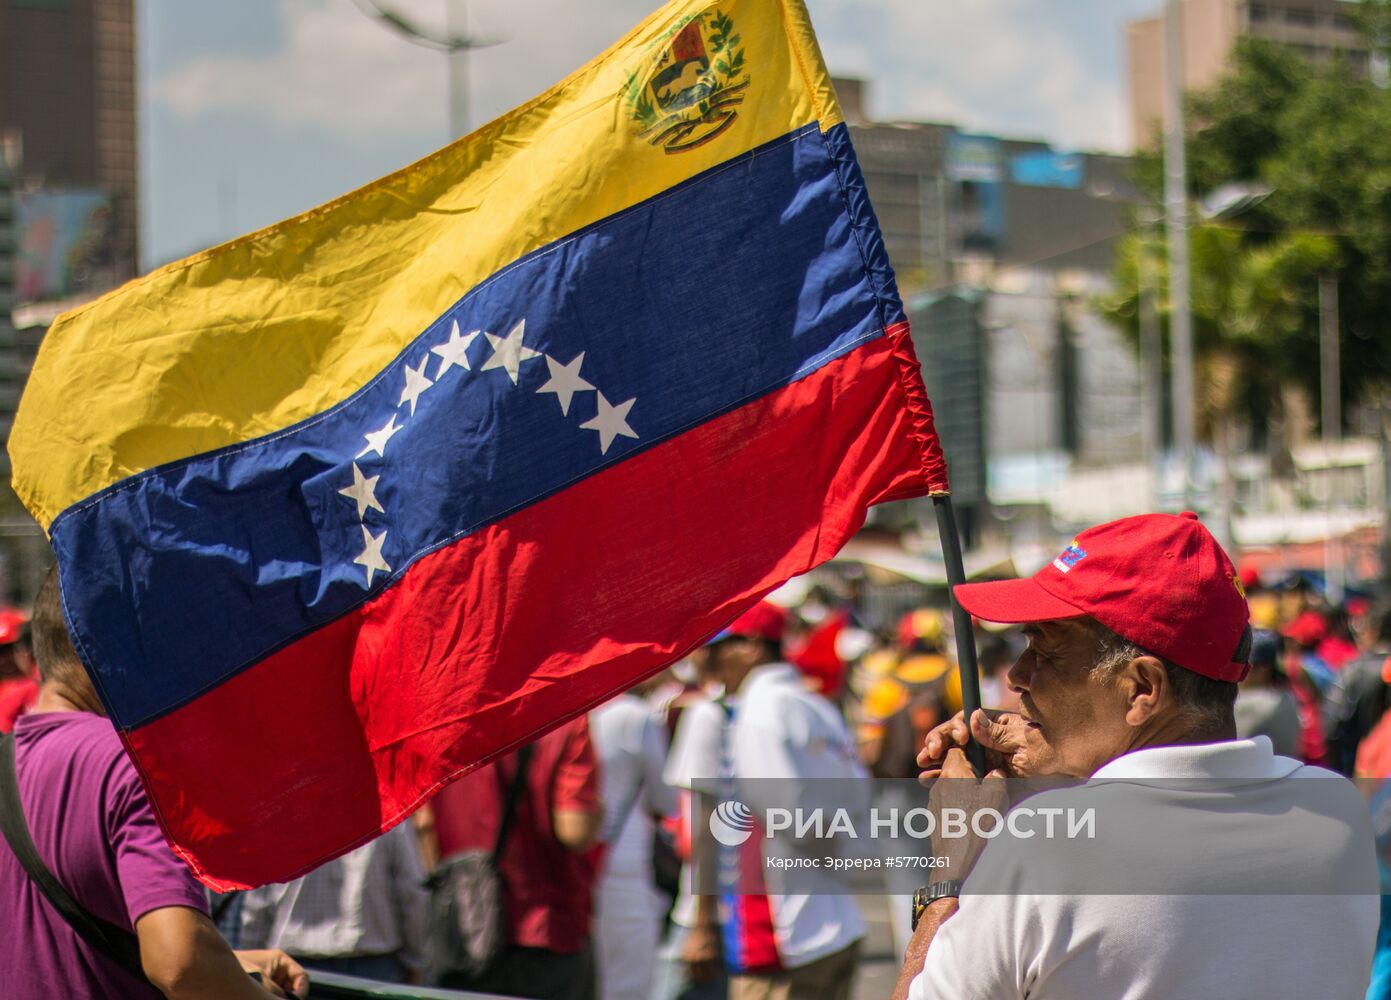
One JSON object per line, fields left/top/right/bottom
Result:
{"left": 14, "top": 189, "right": 115, "bottom": 303}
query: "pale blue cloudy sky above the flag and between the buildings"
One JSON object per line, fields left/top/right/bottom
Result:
{"left": 136, "top": 0, "right": 1161, "bottom": 267}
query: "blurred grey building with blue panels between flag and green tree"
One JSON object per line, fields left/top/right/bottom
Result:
{"left": 836, "top": 79, "right": 1142, "bottom": 544}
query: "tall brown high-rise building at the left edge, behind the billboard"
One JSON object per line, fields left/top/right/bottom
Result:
{"left": 0, "top": 0, "right": 138, "bottom": 604}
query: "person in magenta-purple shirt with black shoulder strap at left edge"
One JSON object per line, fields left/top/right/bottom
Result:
{"left": 0, "top": 573, "right": 309, "bottom": 1000}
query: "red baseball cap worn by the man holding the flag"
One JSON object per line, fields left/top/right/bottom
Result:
{"left": 953, "top": 510, "right": 1251, "bottom": 680}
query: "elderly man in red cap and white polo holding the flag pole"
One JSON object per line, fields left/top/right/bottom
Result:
{"left": 894, "top": 513, "right": 1377, "bottom": 1000}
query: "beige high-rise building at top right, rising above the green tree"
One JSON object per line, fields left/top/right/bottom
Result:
{"left": 1125, "top": 0, "right": 1369, "bottom": 147}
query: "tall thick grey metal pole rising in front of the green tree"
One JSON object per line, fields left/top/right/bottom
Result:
{"left": 1164, "top": 0, "right": 1193, "bottom": 508}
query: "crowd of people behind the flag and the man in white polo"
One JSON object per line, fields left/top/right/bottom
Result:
{"left": 8, "top": 528, "right": 1391, "bottom": 1000}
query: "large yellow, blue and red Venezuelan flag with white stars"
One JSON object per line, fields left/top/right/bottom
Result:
{"left": 10, "top": 0, "right": 947, "bottom": 889}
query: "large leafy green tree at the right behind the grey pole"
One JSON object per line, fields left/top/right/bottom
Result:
{"left": 1103, "top": 37, "right": 1391, "bottom": 427}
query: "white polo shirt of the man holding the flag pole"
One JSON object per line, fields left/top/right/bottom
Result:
{"left": 908, "top": 737, "right": 1378, "bottom": 1000}
